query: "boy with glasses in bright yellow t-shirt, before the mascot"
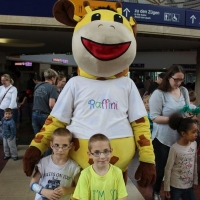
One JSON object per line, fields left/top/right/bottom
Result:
{"left": 73, "top": 133, "right": 128, "bottom": 200}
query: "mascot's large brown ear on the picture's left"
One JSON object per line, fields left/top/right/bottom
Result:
{"left": 53, "top": 0, "right": 78, "bottom": 27}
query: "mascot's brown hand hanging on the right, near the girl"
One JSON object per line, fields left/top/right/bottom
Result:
{"left": 135, "top": 162, "right": 156, "bottom": 187}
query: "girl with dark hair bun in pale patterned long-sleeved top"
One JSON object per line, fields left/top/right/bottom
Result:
{"left": 164, "top": 113, "right": 198, "bottom": 200}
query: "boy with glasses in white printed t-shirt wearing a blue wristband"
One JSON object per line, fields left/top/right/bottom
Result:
{"left": 30, "top": 128, "right": 80, "bottom": 200}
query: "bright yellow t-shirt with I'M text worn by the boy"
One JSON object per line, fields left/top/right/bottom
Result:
{"left": 73, "top": 164, "right": 128, "bottom": 200}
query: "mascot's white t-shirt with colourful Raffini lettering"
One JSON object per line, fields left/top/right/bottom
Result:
{"left": 51, "top": 76, "right": 147, "bottom": 139}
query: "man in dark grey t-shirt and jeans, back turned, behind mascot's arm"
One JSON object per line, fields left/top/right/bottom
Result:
{"left": 32, "top": 69, "right": 58, "bottom": 134}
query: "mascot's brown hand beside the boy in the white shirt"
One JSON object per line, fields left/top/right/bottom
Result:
{"left": 23, "top": 147, "right": 41, "bottom": 176}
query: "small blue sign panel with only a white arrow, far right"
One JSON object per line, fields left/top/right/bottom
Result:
{"left": 186, "top": 10, "right": 200, "bottom": 27}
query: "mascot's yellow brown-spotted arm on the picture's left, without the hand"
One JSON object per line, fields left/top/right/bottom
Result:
{"left": 30, "top": 115, "right": 67, "bottom": 154}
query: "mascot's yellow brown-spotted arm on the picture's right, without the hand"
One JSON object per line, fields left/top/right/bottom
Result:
{"left": 131, "top": 116, "right": 155, "bottom": 164}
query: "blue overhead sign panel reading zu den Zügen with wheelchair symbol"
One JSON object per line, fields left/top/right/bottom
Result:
{"left": 122, "top": 3, "right": 185, "bottom": 26}
